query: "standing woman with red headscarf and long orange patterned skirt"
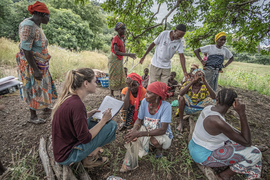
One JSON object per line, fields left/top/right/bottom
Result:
{"left": 16, "top": 1, "right": 57, "bottom": 124}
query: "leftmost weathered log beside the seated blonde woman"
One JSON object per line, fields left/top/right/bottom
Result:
{"left": 39, "top": 137, "right": 55, "bottom": 180}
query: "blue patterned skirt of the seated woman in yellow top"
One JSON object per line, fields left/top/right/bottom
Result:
{"left": 175, "top": 94, "right": 216, "bottom": 116}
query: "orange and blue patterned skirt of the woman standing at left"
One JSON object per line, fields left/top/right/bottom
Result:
{"left": 16, "top": 51, "right": 57, "bottom": 110}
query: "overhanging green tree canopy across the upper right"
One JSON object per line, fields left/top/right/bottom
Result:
{"left": 95, "top": 0, "right": 270, "bottom": 56}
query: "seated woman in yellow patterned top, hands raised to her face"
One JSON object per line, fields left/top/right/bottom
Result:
{"left": 176, "top": 69, "right": 216, "bottom": 132}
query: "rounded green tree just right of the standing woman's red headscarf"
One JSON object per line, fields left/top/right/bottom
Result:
{"left": 42, "top": 7, "right": 93, "bottom": 50}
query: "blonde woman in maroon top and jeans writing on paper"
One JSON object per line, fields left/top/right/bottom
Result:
{"left": 52, "top": 68, "right": 117, "bottom": 168}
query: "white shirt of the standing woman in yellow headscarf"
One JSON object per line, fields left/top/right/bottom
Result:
{"left": 200, "top": 45, "right": 233, "bottom": 59}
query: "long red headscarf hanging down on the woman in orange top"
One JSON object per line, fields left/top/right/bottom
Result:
{"left": 127, "top": 73, "right": 143, "bottom": 124}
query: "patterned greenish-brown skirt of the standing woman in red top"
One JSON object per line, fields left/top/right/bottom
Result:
{"left": 108, "top": 53, "right": 126, "bottom": 90}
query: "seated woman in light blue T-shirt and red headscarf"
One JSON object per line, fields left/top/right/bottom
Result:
{"left": 120, "top": 81, "right": 173, "bottom": 172}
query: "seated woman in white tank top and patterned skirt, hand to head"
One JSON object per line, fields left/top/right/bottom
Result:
{"left": 188, "top": 89, "right": 267, "bottom": 180}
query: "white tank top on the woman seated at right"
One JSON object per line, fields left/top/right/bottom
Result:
{"left": 192, "top": 106, "right": 233, "bottom": 151}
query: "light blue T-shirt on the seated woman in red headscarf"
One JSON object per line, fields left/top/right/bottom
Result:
{"left": 138, "top": 99, "right": 173, "bottom": 139}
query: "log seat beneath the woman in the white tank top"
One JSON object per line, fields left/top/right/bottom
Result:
{"left": 188, "top": 116, "right": 217, "bottom": 180}
